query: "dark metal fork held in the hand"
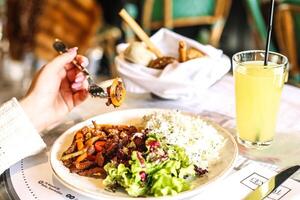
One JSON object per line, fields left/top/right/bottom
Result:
{"left": 53, "top": 39, "right": 108, "bottom": 98}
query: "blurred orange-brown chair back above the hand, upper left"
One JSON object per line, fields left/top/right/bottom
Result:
{"left": 34, "top": 0, "right": 103, "bottom": 60}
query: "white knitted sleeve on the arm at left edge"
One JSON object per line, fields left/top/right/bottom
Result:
{"left": 0, "top": 98, "right": 46, "bottom": 174}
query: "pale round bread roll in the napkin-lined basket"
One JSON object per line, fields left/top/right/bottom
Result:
{"left": 124, "top": 42, "right": 156, "bottom": 66}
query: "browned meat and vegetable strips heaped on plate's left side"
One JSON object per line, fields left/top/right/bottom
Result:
{"left": 62, "top": 122, "right": 146, "bottom": 178}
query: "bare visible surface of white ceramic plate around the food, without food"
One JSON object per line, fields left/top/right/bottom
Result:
{"left": 50, "top": 109, "right": 238, "bottom": 200}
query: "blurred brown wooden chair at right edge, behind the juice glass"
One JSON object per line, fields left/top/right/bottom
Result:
{"left": 275, "top": 0, "right": 300, "bottom": 83}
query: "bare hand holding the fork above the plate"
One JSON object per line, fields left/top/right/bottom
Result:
{"left": 20, "top": 47, "right": 88, "bottom": 131}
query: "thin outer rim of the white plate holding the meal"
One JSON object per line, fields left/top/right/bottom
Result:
{"left": 49, "top": 108, "right": 238, "bottom": 200}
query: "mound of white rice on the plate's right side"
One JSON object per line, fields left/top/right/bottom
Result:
{"left": 143, "top": 111, "right": 225, "bottom": 169}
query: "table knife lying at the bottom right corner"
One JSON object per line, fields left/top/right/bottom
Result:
{"left": 244, "top": 165, "right": 300, "bottom": 200}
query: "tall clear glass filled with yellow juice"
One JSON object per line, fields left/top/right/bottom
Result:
{"left": 232, "top": 50, "right": 288, "bottom": 148}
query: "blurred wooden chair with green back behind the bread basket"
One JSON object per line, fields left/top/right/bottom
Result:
{"left": 142, "top": 0, "right": 232, "bottom": 46}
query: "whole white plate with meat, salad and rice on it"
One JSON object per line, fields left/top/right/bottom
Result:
{"left": 50, "top": 109, "right": 238, "bottom": 199}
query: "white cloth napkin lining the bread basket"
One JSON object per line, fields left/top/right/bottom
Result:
{"left": 115, "top": 28, "right": 231, "bottom": 99}
